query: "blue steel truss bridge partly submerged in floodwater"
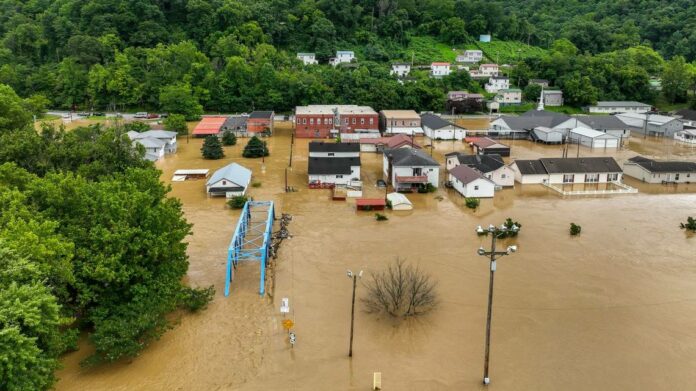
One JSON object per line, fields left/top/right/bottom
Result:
{"left": 225, "top": 201, "right": 275, "bottom": 296}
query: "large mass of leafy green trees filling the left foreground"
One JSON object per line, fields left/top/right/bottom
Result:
{"left": 0, "top": 86, "right": 212, "bottom": 390}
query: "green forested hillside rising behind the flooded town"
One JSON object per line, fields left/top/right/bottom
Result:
{"left": 0, "top": 0, "right": 696, "bottom": 112}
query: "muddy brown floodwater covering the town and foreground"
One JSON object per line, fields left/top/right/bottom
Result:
{"left": 57, "top": 121, "right": 696, "bottom": 391}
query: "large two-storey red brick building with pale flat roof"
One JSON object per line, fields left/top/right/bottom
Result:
{"left": 295, "top": 105, "right": 379, "bottom": 138}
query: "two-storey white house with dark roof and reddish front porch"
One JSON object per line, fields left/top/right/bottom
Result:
{"left": 382, "top": 148, "right": 440, "bottom": 191}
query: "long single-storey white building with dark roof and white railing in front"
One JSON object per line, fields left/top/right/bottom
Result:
{"left": 510, "top": 157, "right": 623, "bottom": 184}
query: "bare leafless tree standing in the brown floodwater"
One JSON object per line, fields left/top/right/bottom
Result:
{"left": 362, "top": 258, "right": 437, "bottom": 317}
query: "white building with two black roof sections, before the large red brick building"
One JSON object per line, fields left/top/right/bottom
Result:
{"left": 307, "top": 141, "right": 360, "bottom": 187}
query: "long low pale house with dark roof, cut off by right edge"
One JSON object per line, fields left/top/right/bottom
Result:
{"left": 624, "top": 156, "right": 696, "bottom": 183}
